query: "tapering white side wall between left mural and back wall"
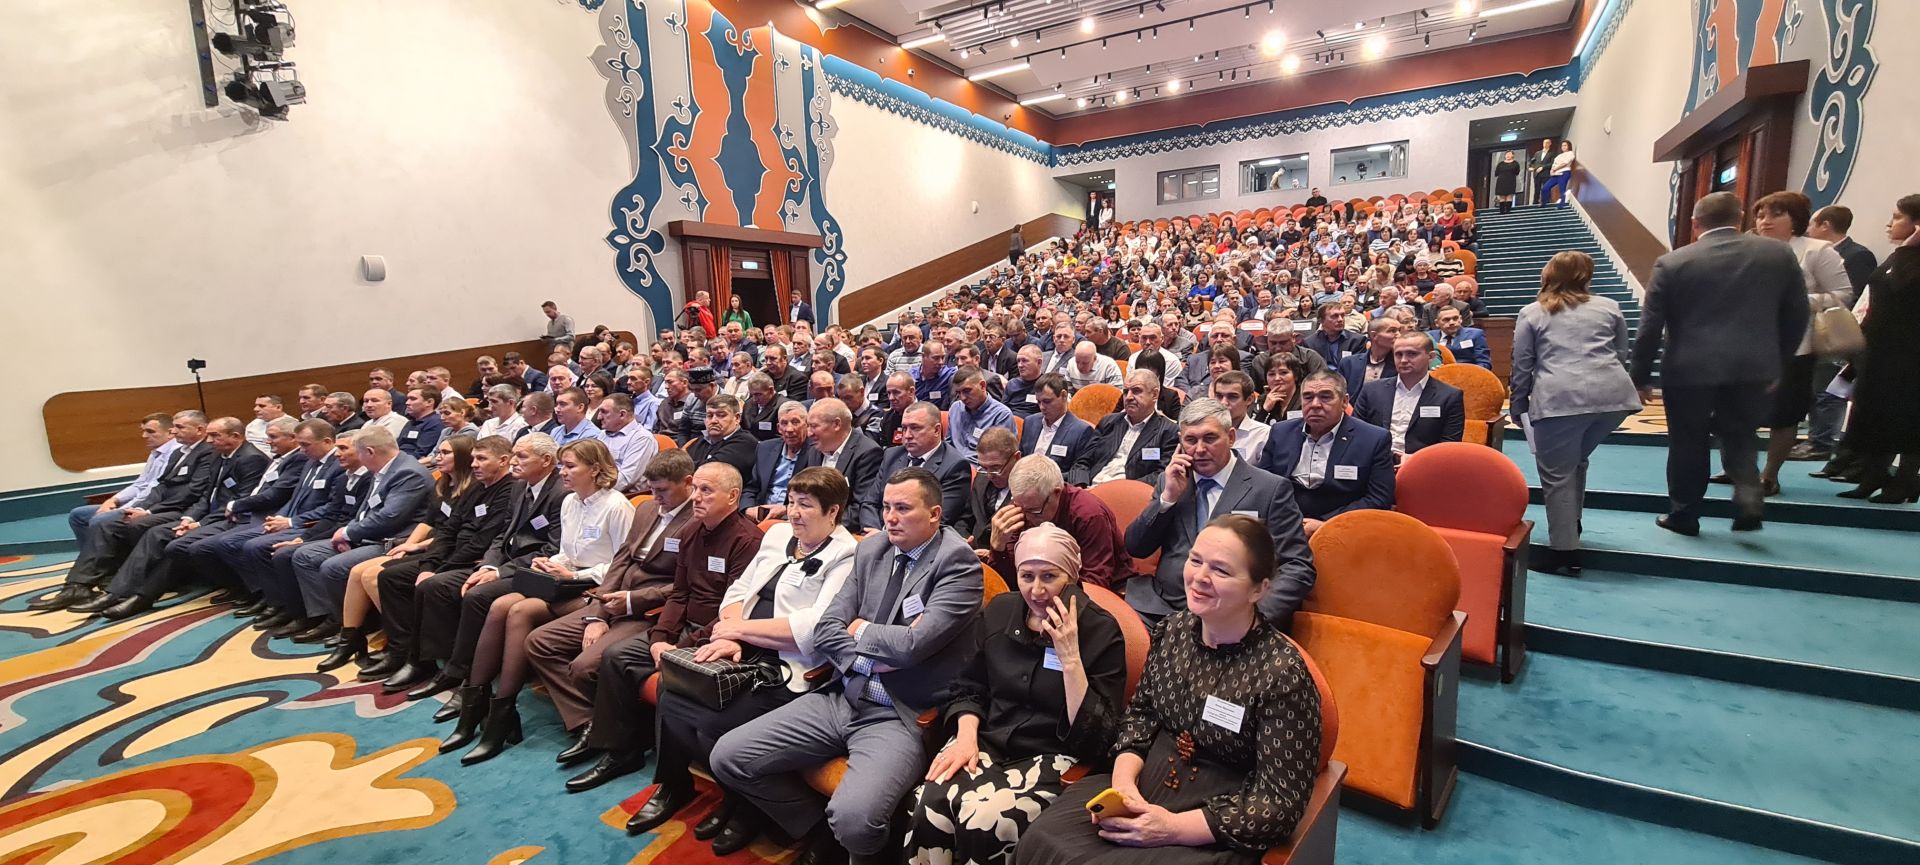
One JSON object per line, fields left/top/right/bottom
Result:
{"left": 826, "top": 96, "right": 1085, "bottom": 308}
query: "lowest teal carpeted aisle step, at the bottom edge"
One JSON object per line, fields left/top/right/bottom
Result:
{"left": 1340, "top": 773, "right": 1818, "bottom": 865}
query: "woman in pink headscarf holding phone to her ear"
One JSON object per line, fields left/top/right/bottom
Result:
{"left": 906, "top": 522, "right": 1127, "bottom": 865}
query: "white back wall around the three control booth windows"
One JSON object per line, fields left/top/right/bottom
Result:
{"left": 1054, "top": 86, "right": 1572, "bottom": 221}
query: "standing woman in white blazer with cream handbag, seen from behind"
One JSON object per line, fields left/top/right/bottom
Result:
{"left": 1753, "top": 192, "right": 1853, "bottom": 495}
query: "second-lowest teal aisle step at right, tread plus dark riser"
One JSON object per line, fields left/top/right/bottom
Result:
{"left": 1459, "top": 654, "right": 1920, "bottom": 863}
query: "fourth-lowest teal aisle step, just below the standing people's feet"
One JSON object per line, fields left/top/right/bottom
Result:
{"left": 1526, "top": 504, "right": 1920, "bottom": 602}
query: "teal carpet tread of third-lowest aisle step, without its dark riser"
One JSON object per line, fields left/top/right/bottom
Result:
{"left": 1526, "top": 568, "right": 1920, "bottom": 677}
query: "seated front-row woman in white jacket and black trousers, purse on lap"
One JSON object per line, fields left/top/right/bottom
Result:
{"left": 626, "top": 466, "right": 856, "bottom": 857}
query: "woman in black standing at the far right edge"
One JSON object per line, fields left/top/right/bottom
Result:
{"left": 1839, "top": 196, "right": 1920, "bottom": 504}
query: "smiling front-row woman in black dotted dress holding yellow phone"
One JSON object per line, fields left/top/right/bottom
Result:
{"left": 1014, "top": 514, "right": 1321, "bottom": 865}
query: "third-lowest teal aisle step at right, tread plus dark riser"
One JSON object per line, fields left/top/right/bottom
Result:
{"left": 1526, "top": 570, "right": 1920, "bottom": 708}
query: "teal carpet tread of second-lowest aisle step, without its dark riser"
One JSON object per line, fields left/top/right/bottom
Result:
{"left": 1459, "top": 654, "right": 1920, "bottom": 840}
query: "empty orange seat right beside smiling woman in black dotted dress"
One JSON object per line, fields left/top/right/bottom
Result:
{"left": 1292, "top": 510, "right": 1467, "bottom": 829}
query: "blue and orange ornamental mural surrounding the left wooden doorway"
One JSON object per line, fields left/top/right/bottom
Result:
{"left": 593, "top": 0, "right": 847, "bottom": 326}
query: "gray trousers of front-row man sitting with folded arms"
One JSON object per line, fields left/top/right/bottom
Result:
{"left": 710, "top": 689, "right": 927, "bottom": 855}
